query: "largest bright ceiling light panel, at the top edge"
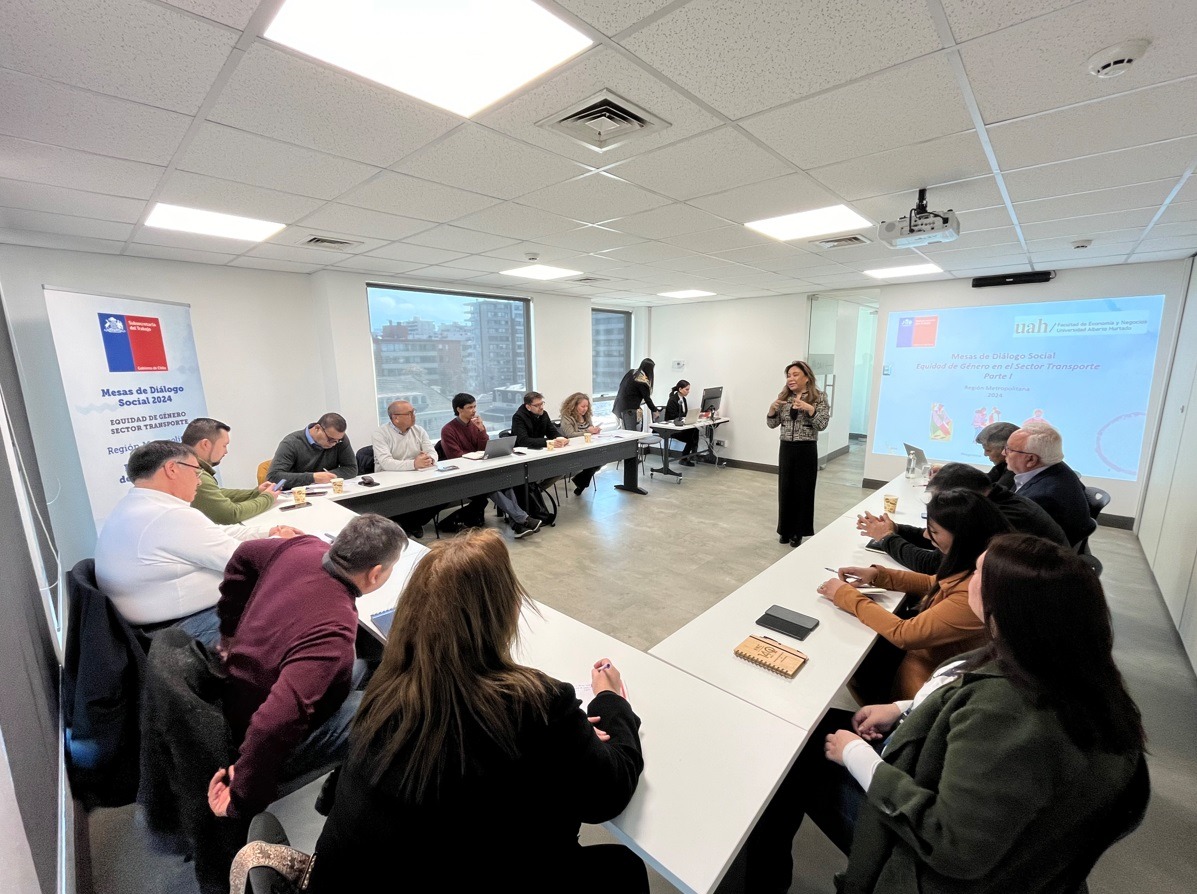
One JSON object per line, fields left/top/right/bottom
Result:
{"left": 266, "top": 0, "right": 591, "bottom": 117}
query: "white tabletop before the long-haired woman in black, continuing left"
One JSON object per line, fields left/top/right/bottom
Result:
{"left": 254, "top": 497, "right": 804, "bottom": 894}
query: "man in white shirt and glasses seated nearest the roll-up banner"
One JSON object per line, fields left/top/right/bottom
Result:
{"left": 96, "top": 440, "right": 300, "bottom": 645}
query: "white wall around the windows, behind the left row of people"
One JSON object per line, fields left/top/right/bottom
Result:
{"left": 0, "top": 245, "right": 598, "bottom": 567}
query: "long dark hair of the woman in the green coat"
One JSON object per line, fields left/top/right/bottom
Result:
{"left": 980, "top": 534, "right": 1146, "bottom": 754}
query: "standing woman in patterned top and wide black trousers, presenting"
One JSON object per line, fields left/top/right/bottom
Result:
{"left": 765, "top": 360, "right": 831, "bottom": 547}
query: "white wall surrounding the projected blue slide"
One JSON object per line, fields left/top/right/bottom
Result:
{"left": 864, "top": 261, "right": 1189, "bottom": 517}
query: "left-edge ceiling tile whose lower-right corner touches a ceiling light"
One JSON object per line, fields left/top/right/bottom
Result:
{"left": 0, "top": 136, "right": 165, "bottom": 199}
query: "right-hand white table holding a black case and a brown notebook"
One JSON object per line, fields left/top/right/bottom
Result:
{"left": 649, "top": 479, "right": 909, "bottom": 736}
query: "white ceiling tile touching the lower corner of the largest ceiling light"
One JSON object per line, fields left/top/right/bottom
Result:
{"left": 394, "top": 122, "right": 587, "bottom": 199}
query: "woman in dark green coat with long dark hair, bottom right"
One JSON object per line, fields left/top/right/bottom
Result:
{"left": 746, "top": 534, "right": 1148, "bottom": 894}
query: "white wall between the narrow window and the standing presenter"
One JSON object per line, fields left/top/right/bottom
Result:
{"left": 649, "top": 294, "right": 808, "bottom": 466}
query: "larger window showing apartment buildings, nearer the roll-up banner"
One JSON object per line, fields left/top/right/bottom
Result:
{"left": 366, "top": 286, "right": 531, "bottom": 438}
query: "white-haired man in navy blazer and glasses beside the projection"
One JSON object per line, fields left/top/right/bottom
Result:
{"left": 1002, "top": 422, "right": 1098, "bottom": 547}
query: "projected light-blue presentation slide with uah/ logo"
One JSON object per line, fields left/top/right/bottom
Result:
{"left": 873, "top": 294, "right": 1163, "bottom": 481}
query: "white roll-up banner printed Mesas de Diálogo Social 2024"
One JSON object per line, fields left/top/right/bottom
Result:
{"left": 43, "top": 286, "right": 207, "bottom": 533}
